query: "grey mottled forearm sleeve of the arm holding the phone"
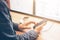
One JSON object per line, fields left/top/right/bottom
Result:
{"left": 18, "top": 30, "right": 38, "bottom": 40}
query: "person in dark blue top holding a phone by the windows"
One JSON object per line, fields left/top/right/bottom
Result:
{"left": 0, "top": 0, "right": 45, "bottom": 40}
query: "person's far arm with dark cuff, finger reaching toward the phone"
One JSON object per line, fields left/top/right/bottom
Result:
{"left": 13, "top": 22, "right": 35, "bottom": 31}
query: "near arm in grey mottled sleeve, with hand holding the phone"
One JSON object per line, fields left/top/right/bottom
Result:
{"left": 17, "top": 21, "right": 47, "bottom": 40}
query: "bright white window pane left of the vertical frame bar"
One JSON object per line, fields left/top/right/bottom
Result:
{"left": 10, "top": 0, "right": 33, "bottom": 14}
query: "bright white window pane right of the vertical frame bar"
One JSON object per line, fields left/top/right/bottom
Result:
{"left": 35, "top": 0, "right": 60, "bottom": 21}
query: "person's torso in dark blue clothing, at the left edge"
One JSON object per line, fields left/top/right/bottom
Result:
{"left": 0, "top": 0, "right": 16, "bottom": 40}
